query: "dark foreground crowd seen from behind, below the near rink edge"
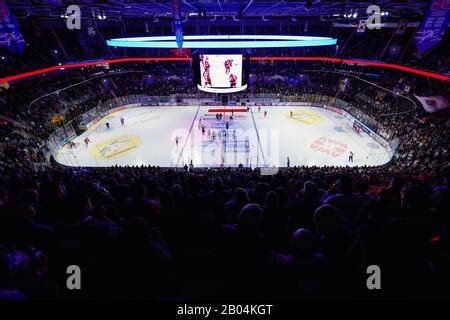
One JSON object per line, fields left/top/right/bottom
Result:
{"left": 0, "top": 167, "right": 450, "bottom": 299}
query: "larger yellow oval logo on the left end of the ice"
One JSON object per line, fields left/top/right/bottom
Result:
{"left": 90, "top": 135, "right": 141, "bottom": 160}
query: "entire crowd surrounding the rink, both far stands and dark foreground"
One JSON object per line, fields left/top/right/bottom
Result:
{"left": 0, "top": 60, "right": 450, "bottom": 299}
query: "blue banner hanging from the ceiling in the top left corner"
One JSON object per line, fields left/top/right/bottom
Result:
{"left": 0, "top": 0, "right": 25, "bottom": 54}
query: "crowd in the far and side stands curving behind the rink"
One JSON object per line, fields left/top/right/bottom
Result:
{"left": 0, "top": 62, "right": 449, "bottom": 168}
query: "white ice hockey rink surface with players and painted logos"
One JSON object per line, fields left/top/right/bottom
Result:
{"left": 55, "top": 106, "right": 392, "bottom": 167}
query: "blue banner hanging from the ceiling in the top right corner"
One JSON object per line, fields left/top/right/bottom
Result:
{"left": 414, "top": 0, "right": 450, "bottom": 55}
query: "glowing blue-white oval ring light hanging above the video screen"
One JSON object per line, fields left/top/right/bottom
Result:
{"left": 106, "top": 35, "right": 336, "bottom": 49}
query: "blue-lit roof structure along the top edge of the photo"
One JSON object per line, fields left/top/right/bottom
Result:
{"left": 8, "top": 0, "right": 428, "bottom": 20}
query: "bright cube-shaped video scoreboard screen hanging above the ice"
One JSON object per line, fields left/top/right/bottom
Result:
{"left": 197, "top": 54, "right": 247, "bottom": 93}
